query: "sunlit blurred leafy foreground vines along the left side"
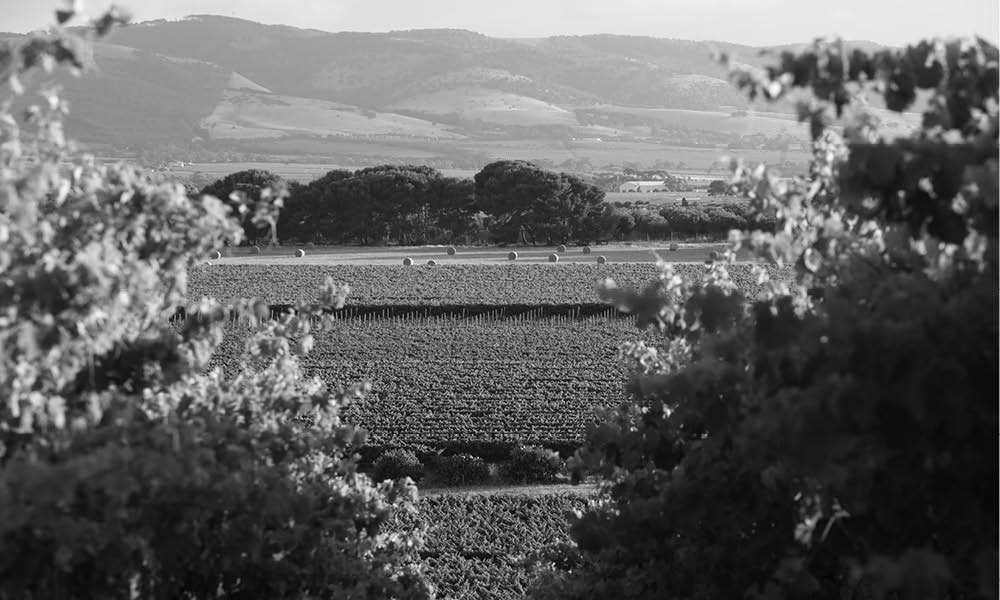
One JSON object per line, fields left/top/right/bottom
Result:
{"left": 0, "top": 9, "right": 432, "bottom": 599}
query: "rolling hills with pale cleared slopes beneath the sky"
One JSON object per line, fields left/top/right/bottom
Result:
{"left": 3, "top": 15, "right": 912, "bottom": 166}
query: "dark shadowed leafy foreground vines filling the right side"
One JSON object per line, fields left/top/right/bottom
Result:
{"left": 531, "top": 40, "right": 1000, "bottom": 599}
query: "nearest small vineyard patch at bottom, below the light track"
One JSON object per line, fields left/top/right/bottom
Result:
{"left": 390, "top": 493, "right": 587, "bottom": 600}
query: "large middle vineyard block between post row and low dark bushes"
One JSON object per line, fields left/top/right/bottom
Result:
{"left": 216, "top": 315, "right": 656, "bottom": 448}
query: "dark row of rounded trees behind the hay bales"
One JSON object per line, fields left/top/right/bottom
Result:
{"left": 197, "top": 160, "right": 760, "bottom": 245}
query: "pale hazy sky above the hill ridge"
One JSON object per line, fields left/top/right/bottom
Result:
{"left": 0, "top": 0, "right": 1000, "bottom": 45}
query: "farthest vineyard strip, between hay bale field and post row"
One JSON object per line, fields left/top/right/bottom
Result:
{"left": 188, "top": 261, "right": 779, "bottom": 307}
